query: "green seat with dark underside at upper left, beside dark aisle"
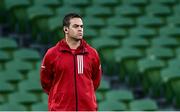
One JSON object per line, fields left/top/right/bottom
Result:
{"left": 27, "top": 5, "right": 54, "bottom": 43}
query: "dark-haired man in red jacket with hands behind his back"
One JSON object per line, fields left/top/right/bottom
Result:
{"left": 40, "top": 13, "right": 102, "bottom": 111}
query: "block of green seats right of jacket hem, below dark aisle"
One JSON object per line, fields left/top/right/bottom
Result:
{"left": 96, "top": 80, "right": 159, "bottom": 111}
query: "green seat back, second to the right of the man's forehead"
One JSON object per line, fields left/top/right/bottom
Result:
{"left": 107, "top": 15, "right": 135, "bottom": 28}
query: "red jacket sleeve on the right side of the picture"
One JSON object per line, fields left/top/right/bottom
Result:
{"left": 92, "top": 50, "right": 102, "bottom": 91}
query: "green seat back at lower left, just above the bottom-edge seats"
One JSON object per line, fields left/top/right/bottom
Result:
{"left": 9, "top": 91, "right": 37, "bottom": 106}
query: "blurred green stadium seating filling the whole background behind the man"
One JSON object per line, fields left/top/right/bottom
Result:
{"left": 0, "top": 0, "right": 180, "bottom": 111}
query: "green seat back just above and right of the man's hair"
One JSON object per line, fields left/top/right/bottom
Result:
{"left": 85, "top": 5, "right": 112, "bottom": 17}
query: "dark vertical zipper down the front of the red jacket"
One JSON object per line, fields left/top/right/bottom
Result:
{"left": 73, "top": 54, "right": 78, "bottom": 111}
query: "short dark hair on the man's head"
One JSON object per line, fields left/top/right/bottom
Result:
{"left": 63, "top": 13, "right": 82, "bottom": 27}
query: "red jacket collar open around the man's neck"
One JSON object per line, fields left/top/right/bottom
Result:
{"left": 56, "top": 39, "right": 88, "bottom": 54}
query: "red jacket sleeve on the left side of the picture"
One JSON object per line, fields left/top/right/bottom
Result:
{"left": 40, "top": 50, "right": 53, "bottom": 94}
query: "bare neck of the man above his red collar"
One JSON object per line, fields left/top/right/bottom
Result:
{"left": 66, "top": 37, "right": 81, "bottom": 49}
